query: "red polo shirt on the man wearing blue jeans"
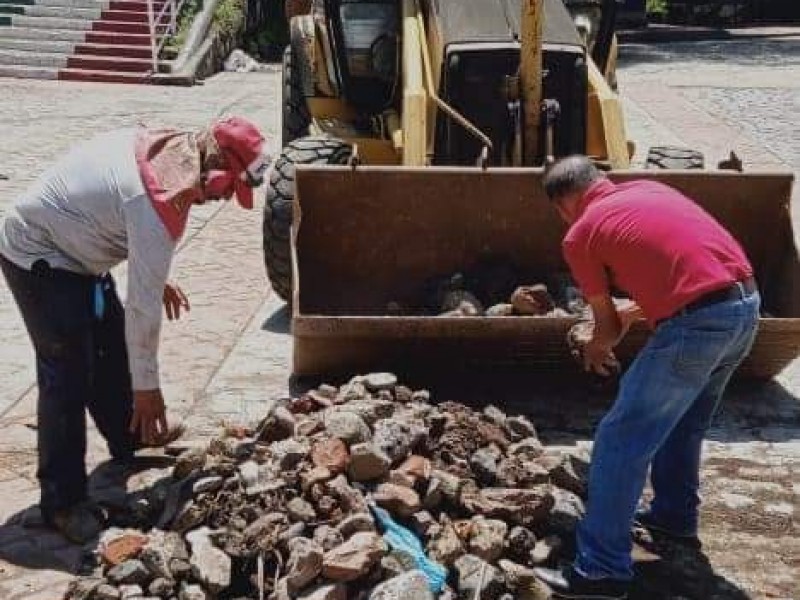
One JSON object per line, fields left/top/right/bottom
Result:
{"left": 563, "top": 179, "right": 753, "bottom": 325}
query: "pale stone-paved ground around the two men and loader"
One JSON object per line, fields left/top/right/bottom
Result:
{"left": 0, "top": 30, "right": 800, "bottom": 600}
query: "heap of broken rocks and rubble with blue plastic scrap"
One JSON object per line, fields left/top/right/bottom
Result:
{"left": 67, "top": 373, "right": 588, "bottom": 600}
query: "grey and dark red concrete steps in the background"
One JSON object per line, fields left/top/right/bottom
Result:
{"left": 0, "top": 0, "right": 170, "bottom": 83}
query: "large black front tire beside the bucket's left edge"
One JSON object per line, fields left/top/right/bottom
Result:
{"left": 263, "top": 136, "right": 353, "bottom": 302}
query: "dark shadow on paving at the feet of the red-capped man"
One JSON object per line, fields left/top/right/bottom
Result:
{"left": 0, "top": 456, "right": 174, "bottom": 575}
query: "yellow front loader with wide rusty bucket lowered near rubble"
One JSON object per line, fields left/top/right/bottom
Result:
{"left": 264, "top": 0, "right": 800, "bottom": 377}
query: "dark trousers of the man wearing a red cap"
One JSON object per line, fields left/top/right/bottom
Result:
{"left": 0, "top": 256, "right": 134, "bottom": 516}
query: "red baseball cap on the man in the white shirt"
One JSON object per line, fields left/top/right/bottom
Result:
{"left": 211, "top": 117, "right": 270, "bottom": 208}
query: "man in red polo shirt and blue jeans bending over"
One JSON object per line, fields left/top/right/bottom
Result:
{"left": 538, "top": 156, "right": 760, "bottom": 598}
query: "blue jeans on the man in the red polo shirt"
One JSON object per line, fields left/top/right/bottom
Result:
{"left": 575, "top": 290, "right": 760, "bottom": 579}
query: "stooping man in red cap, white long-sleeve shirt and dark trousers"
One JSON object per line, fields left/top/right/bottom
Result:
{"left": 0, "top": 117, "right": 267, "bottom": 541}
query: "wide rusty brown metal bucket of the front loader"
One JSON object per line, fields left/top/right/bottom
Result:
{"left": 292, "top": 166, "right": 800, "bottom": 378}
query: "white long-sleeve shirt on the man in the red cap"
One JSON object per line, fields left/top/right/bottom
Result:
{"left": 0, "top": 129, "right": 176, "bottom": 390}
